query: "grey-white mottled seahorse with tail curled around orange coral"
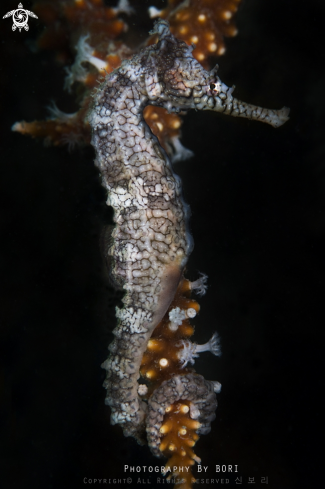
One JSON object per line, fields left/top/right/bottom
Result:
{"left": 88, "top": 20, "right": 289, "bottom": 482}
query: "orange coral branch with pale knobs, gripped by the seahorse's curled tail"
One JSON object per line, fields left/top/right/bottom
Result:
{"left": 140, "top": 278, "right": 208, "bottom": 489}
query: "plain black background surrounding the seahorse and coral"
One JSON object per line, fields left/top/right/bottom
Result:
{"left": 0, "top": 0, "right": 325, "bottom": 489}
